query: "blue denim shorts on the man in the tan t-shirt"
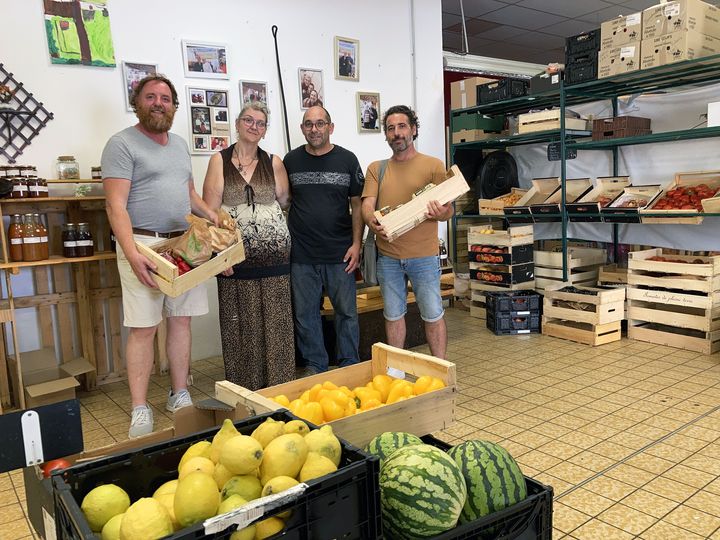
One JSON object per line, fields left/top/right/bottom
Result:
{"left": 377, "top": 254, "right": 445, "bottom": 323}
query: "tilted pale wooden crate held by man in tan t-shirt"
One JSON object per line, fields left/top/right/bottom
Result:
{"left": 375, "top": 165, "right": 470, "bottom": 242}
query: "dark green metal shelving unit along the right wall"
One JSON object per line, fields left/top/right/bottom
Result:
{"left": 450, "top": 54, "right": 720, "bottom": 279}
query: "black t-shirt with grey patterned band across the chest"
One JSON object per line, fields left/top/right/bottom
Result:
{"left": 283, "top": 145, "right": 365, "bottom": 264}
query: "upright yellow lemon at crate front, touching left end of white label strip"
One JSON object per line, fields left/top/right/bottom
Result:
{"left": 173, "top": 472, "right": 220, "bottom": 527}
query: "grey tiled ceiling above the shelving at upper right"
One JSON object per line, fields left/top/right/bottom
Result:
{"left": 442, "top": 0, "right": 720, "bottom": 64}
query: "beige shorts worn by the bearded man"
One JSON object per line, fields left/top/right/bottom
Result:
{"left": 116, "top": 234, "right": 208, "bottom": 328}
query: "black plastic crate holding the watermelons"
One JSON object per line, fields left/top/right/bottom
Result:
{"left": 422, "top": 435, "right": 553, "bottom": 540}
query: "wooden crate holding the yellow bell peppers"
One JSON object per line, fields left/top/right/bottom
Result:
{"left": 215, "top": 343, "right": 457, "bottom": 448}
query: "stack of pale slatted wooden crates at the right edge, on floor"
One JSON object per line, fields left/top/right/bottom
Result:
{"left": 627, "top": 248, "right": 720, "bottom": 354}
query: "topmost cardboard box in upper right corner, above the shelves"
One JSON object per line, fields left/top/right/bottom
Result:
{"left": 642, "top": 0, "right": 720, "bottom": 40}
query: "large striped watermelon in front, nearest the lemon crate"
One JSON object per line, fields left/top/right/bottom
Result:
{"left": 380, "top": 444, "right": 467, "bottom": 539}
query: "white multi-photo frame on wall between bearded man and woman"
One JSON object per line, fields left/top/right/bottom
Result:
{"left": 186, "top": 86, "right": 232, "bottom": 155}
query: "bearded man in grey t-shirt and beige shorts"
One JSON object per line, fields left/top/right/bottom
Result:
{"left": 102, "top": 75, "right": 218, "bottom": 437}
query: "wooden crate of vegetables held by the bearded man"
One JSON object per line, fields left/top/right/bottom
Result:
{"left": 135, "top": 231, "right": 245, "bottom": 298}
